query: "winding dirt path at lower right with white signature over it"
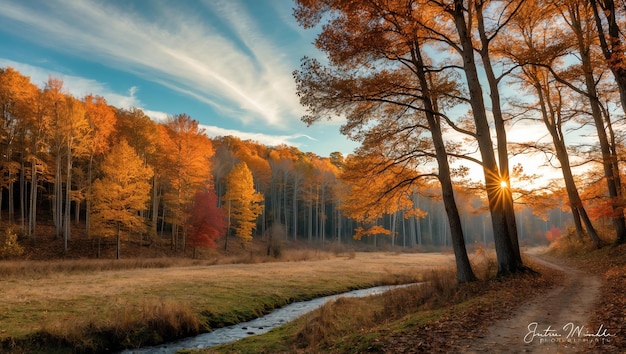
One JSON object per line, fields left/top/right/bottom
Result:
{"left": 463, "top": 256, "right": 610, "bottom": 353}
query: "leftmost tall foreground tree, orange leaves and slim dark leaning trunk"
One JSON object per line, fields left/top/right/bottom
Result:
{"left": 294, "top": 0, "right": 478, "bottom": 282}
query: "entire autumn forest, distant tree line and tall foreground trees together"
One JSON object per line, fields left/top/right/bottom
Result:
{"left": 0, "top": 1, "right": 626, "bottom": 279}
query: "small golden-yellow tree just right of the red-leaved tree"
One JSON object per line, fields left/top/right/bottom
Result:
{"left": 223, "top": 162, "right": 264, "bottom": 246}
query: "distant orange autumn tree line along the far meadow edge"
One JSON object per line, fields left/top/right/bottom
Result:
{"left": 0, "top": 68, "right": 563, "bottom": 257}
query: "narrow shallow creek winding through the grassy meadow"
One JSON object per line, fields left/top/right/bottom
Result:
{"left": 122, "top": 283, "right": 419, "bottom": 354}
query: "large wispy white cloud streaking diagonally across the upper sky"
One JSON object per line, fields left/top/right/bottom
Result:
{"left": 0, "top": 0, "right": 302, "bottom": 128}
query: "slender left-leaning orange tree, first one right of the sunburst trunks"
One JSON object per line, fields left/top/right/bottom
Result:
{"left": 500, "top": 2, "right": 600, "bottom": 245}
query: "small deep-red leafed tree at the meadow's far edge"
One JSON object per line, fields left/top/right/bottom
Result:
{"left": 187, "top": 191, "right": 226, "bottom": 257}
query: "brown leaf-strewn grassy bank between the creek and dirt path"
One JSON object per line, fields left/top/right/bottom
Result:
{"left": 213, "top": 249, "right": 553, "bottom": 353}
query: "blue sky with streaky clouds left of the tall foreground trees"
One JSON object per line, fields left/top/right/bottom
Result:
{"left": 0, "top": 0, "right": 357, "bottom": 156}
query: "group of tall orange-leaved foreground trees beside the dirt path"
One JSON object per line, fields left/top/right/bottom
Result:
{"left": 294, "top": 0, "right": 626, "bottom": 282}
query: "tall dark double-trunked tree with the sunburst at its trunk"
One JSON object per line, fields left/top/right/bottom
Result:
{"left": 402, "top": 0, "right": 526, "bottom": 275}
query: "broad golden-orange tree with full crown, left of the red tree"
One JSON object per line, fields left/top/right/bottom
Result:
{"left": 90, "top": 140, "right": 153, "bottom": 259}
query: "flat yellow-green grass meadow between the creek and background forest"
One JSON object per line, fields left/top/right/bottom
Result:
{"left": 0, "top": 253, "right": 453, "bottom": 351}
